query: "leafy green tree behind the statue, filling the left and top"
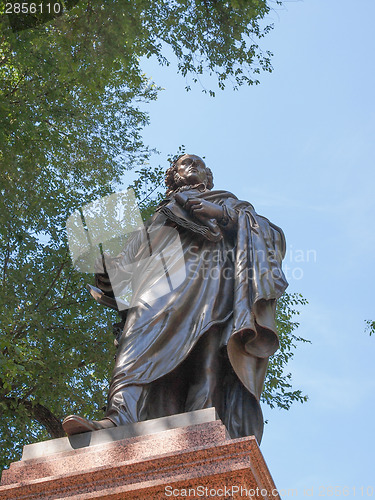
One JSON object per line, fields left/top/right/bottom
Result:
{"left": 0, "top": 0, "right": 312, "bottom": 467}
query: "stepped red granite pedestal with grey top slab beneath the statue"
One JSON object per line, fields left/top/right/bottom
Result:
{"left": 0, "top": 409, "right": 279, "bottom": 500}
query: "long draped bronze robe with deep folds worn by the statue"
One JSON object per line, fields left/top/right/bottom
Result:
{"left": 98, "top": 190, "right": 287, "bottom": 442}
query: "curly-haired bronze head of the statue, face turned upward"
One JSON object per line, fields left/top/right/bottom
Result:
{"left": 165, "top": 154, "right": 214, "bottom": 195}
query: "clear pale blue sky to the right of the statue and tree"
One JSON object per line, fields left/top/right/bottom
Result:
{"left": 130, "top": 0, "right": 375, "bottom": 498}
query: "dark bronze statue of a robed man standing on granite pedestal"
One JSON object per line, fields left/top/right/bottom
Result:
{"left": 63, "top": 154, "right": 287, "bottom": 442}
